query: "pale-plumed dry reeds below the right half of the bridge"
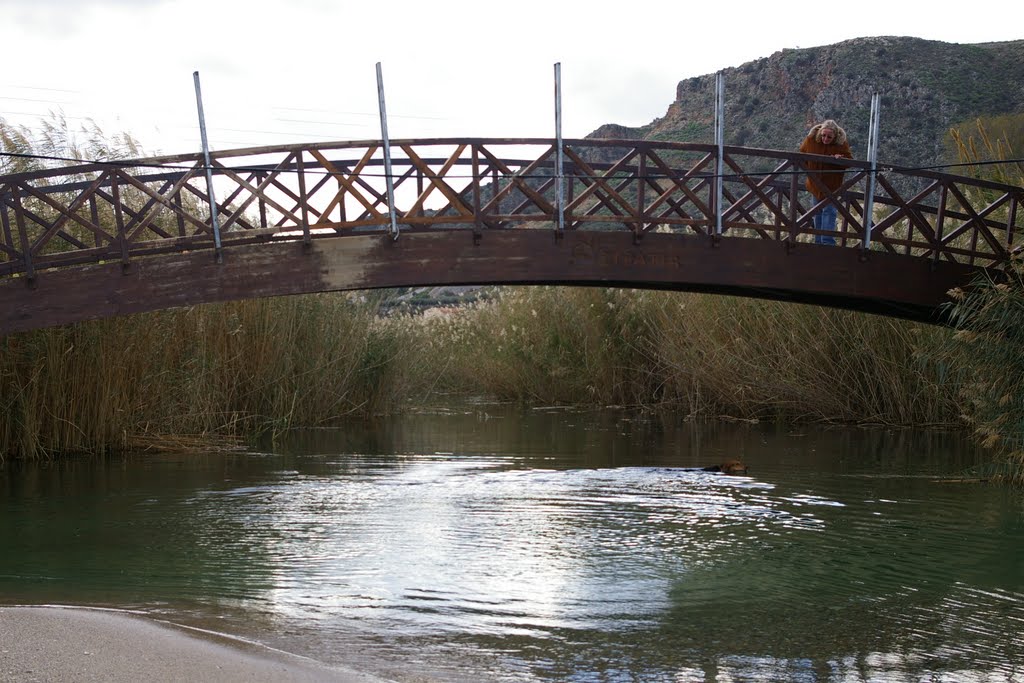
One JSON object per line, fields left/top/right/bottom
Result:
{"left": 417, "top": 288, "right": 962, "bottom": 426}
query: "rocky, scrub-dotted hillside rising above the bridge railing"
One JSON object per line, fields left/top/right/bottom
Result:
{"left": 588, "top": 37, "right": 1024, "bottom": 172}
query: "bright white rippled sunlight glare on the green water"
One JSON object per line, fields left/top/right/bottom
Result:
{"left": 234, "top": 458, "right": 782, "bottom": 635}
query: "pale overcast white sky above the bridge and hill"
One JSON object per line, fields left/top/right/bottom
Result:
{"left": 0, "top": 0, "right": 1024, "bottom": 154}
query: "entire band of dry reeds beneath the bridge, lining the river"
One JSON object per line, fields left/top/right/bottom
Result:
{"left": 0, "top": 287, "right": 964, "bottom": 458}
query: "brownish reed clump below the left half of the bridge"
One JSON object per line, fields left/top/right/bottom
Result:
{"left": 0, "top": 295, "right": 434, "bottom": 458}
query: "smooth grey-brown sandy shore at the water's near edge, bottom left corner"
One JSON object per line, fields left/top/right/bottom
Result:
{"left": 0, "top": 607, "right": 391, "bottom": 683}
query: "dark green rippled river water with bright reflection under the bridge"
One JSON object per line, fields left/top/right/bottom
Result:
{"left": 0, "top": 404, "right": 1024, "bottom": 682}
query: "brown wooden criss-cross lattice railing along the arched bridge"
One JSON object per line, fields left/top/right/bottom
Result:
{"left": 0, "top": 138, "right": 1024, "bottom": 278}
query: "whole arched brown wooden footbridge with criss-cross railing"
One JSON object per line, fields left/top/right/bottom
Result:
{"left": 0, "top": 138, "right": 1024, "bottom": 335}
